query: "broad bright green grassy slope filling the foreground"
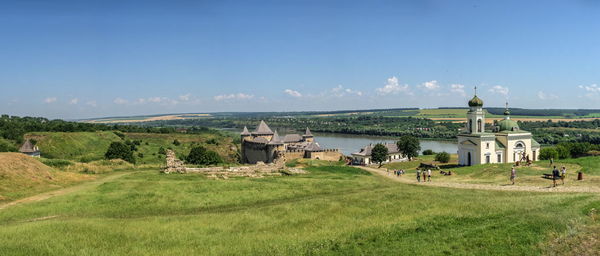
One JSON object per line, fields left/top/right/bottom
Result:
{"left": 0, "top": 163, "right": 600, "bottom": 255}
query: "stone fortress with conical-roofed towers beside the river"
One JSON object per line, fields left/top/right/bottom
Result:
{"left": 240, "top": 121, "right": 343, "bottom": 164}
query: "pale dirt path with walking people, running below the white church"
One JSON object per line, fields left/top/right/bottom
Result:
{"left": 359, "top": 166, "right": 600, "bottom": 193}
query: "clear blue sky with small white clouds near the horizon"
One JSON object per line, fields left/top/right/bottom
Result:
{"left": 0, "top": 0, "right": 600, "bottom": 119}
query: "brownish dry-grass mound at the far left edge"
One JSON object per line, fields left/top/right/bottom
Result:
{"left": 0, "top": 153, "right": 94, "bottom": 202}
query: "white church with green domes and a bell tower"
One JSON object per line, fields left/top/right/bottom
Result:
{"left": 458, "top": 92, "right": 540, "bottom": 166}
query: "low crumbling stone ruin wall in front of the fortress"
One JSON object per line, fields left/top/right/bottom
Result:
{"left": 162, "top": 150, "right": 306, "bottom": 179}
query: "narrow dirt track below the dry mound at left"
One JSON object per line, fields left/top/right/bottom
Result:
{"left": 0, "top": 172, "right": 132, "bottom": 210}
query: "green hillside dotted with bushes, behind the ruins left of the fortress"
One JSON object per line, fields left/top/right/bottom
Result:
{"left": 26, "top": 132, "right": 237, "bottom": 164}
